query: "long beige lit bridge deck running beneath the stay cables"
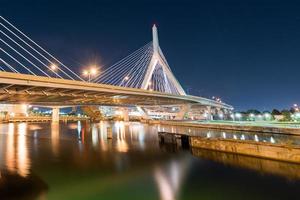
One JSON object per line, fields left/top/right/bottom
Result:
{"left": 0, "top": 72, "right": 232, "bottom": 109}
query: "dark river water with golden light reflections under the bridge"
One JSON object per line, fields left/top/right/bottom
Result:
{"left": 0, "top": 122, "right": 300, "bottom": 200}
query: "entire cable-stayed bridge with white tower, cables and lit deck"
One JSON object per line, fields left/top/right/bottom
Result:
{"left": 0, "top": 17, "right": 232, "bottom": 119}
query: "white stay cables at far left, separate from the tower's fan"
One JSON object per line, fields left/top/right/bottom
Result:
{"left": 0, "top": 16, "right": 83, "bottom": 81}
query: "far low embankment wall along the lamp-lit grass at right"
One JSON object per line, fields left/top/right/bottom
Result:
{"left": 149, "top": 121, "right": 300, "bottom": 135}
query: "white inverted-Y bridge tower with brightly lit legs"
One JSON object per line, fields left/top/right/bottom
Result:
{"left": 142, "top": 24, "right": 186, "bottom": 95}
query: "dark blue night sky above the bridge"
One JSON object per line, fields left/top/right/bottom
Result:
{"left": 0, "top": 0, "right": 300, "bottom": 110}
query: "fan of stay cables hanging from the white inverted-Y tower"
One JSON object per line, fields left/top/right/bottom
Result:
{"left": 94, "top": 42, "right": 180, "bottom": 94}
